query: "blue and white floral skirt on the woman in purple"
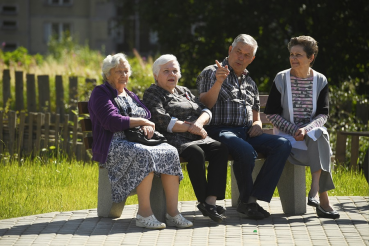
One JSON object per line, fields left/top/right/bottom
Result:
{"left": 100, "top": 132, "right": 183, "bottom": 203}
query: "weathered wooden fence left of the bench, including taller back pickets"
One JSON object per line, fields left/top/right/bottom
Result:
{"left": 0, "top": 70, "right": 96, "bottom": 160}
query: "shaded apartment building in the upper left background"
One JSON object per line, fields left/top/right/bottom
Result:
{"left": 0, "top": 0, "right": 157, "bottom": 54}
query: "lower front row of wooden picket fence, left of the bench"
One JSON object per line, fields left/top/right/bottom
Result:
{"left": 0, "top": 111, "right": 90, "bottom": 161}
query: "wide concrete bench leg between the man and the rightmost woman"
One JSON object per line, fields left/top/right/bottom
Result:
{"left": 277, "top": 161, "right": 306, "bottom": 215}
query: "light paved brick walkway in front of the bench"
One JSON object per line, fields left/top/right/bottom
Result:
{"left": 0, "top": 196, "right": 369, "bottom": 246}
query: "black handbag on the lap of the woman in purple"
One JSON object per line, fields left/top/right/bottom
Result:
{"left": 124, "top": 127, "right": 167, "bottom": 146}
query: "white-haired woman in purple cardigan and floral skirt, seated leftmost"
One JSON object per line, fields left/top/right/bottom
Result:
{"left": 88, "top": 53, "right": 192, "bottom": 229}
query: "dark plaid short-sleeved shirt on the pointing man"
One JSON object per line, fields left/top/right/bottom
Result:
{"left": 196, "top": 58, "right": 260, "bottom": 126}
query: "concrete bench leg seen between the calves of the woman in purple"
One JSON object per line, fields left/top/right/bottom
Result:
{"left": 150, "top": 175, "right": 167, "bottom": 223}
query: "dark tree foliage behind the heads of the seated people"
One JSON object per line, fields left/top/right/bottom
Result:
{"left": 119, "top": 0, "right": 369, "bottom": 94}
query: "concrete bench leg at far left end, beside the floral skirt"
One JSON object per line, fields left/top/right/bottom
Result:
{"left": 97, "top": 168, "right": 125, "bottom": 218}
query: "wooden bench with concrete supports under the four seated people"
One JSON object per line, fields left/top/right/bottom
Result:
{"left": 78, "top": 95, "right": 306, "bottom": 221}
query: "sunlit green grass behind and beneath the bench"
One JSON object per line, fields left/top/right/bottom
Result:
{"left": 0, "top": 158, "right": 368, "bottom": 219}
